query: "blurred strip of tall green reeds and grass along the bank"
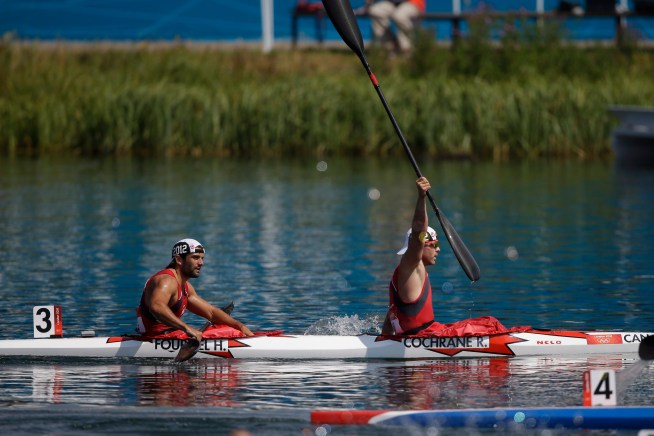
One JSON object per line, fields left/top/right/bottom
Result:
{"left": 0, "top": 20, "right": 654, "bottom": 160}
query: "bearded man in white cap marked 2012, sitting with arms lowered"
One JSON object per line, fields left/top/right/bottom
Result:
{"left": 136, "top": 239, "right": 252, "bottom": 340}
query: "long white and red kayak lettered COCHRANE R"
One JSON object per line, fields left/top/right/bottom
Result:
{"left": 0, "top": 330, "right": 654, "bottom": 359}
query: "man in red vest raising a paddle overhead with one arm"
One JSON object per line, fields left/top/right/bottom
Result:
{"left": 382, "top": 177, "right": 440, "bottom": 335}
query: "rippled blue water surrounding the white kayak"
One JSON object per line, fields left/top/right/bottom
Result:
{"left": 0, "top": 158, "right": 654, "bottom": 434}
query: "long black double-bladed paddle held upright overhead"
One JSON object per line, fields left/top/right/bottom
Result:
{"left": 322, "top": 0, "right": 479, "bottom": 282}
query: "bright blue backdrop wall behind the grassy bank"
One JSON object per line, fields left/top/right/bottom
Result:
{"left": 0, "top": 0, "right": 654, "bottom": 42}
